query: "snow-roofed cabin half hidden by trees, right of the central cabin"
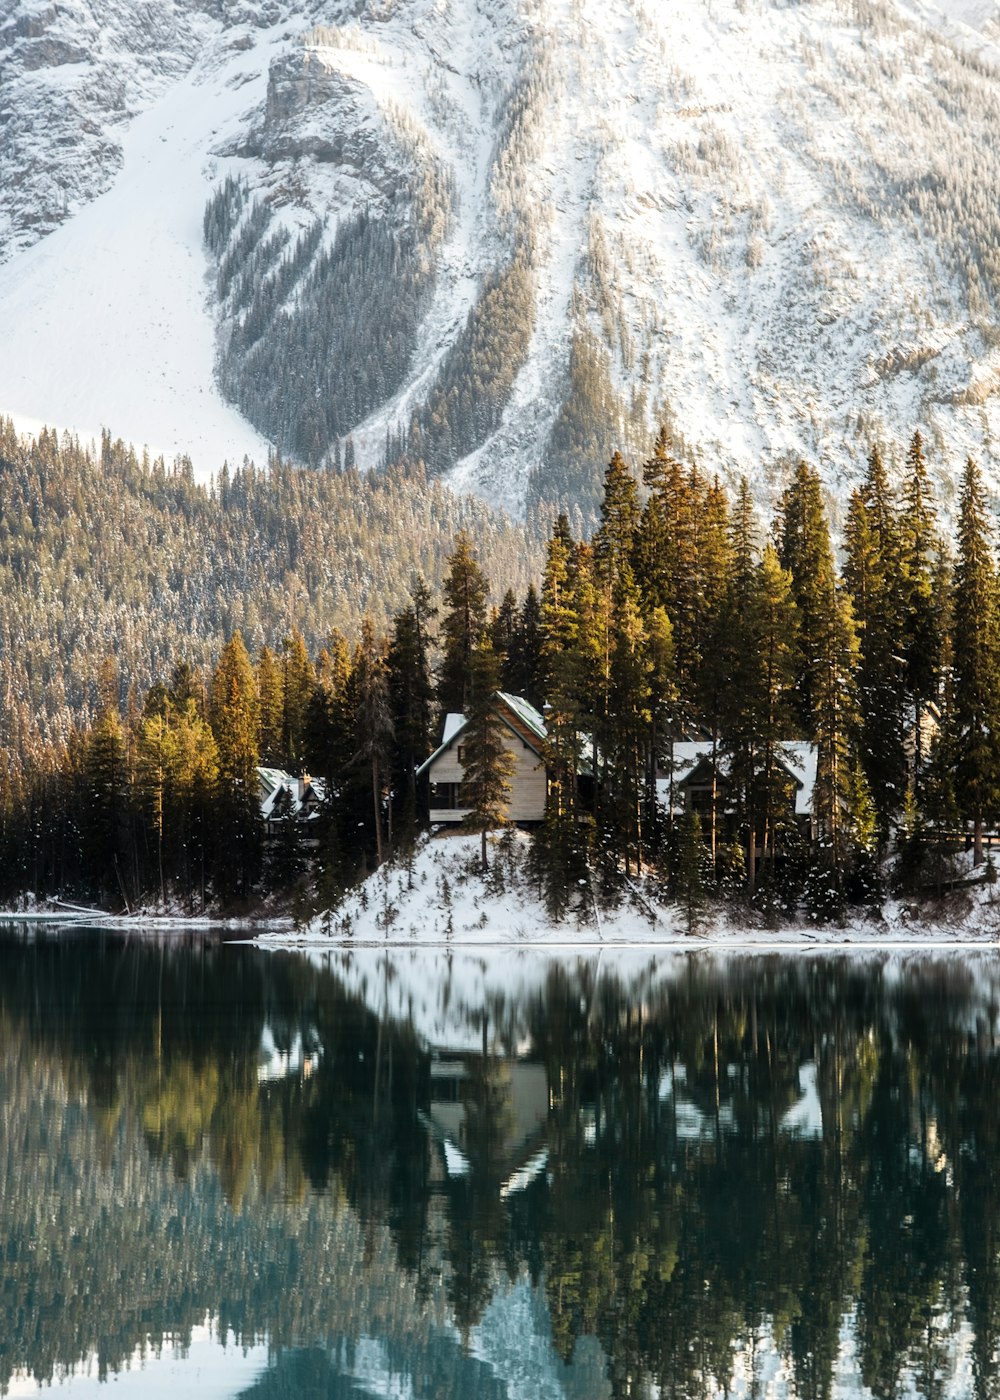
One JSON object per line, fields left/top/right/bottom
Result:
{"left": 657, "top": 739, "right": 817, "bottom": 840}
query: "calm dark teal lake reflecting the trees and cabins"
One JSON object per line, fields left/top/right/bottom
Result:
{"left": 0, "top": 927, "right": 1000, "bottom": 1400}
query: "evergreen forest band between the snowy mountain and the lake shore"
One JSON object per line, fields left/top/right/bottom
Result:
{"left": 0, "top": 420, "right": 1000, "bottom": 928}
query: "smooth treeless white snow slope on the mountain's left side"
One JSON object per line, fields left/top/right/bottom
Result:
{"left": 0, "top": 9, "right": 280, "bottom": 480}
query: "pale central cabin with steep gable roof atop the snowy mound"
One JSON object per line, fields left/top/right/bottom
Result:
{"left": 417, "top": 690, "right": 546, "bottom": 822}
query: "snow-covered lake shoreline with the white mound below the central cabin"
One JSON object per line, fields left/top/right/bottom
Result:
{"left": 7, "top": 834, "right": 1000, "bottom": 955}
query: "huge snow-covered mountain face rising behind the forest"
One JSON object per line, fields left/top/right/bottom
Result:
{"left": 0, "top": 0, "right": 1000, "bottom": 520}
